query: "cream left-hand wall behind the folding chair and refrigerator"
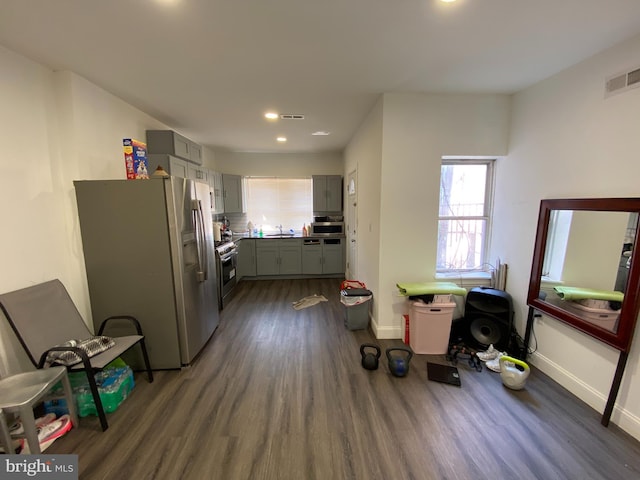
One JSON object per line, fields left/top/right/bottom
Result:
{"left": 0, "top": 47, "right": 175, "bottom": 374}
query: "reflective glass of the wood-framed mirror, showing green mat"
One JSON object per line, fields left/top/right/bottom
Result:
{"left": 538, "top": 210, "right": 638, "bottom": 333}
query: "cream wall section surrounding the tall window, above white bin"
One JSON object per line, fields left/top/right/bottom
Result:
{"left": 372, "top": 93, "right": 510, "bottom": 338}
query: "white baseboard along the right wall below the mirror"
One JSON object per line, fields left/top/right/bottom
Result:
{"left": 529, "top": 353, "right": 640, "bottom": 440}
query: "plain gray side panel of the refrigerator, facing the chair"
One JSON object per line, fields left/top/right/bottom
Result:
{"left": 74, "top": 179, "right": 182, "bottom": 369}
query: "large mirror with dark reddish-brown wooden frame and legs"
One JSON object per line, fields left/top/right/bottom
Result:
{"left": 525, "top": 198, "right": 640, "bottom": 425}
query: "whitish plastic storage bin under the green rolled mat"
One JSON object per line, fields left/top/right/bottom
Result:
{"left": 409, "top": 302, "right": 456, "bottom": 355}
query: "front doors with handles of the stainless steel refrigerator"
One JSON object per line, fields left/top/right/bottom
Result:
{"left": 170, "top": 177, "right": 219, "bottom": 365}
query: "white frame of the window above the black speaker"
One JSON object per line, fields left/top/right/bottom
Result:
{"left": 436, "top": 157, "right": 497, "bottom": 275}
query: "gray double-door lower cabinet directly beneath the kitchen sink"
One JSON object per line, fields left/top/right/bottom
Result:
{"left": 256, "top": 238, "right": 302, "bottom": 276}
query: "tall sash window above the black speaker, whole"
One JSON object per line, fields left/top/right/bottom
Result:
{"left": 436, "top": 159, "right": 495, "bottom": 272}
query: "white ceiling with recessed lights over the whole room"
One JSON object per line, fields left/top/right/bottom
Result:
{"left": 0, "top": 0, "right": 640, "bottom": 152}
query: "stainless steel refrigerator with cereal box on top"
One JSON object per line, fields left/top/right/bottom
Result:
{"left": 73, "top": 177, "right": 219, "bottom": 370}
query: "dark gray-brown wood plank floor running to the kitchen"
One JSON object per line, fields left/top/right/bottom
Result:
{"left": 47, "top": 279, "right": 640, "bottom": 480}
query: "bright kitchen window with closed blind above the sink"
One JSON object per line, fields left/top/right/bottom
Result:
{"left": 245, "top": 177, "right": 313, "bottom": 233}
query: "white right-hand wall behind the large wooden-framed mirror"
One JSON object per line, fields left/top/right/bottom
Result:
{"left": 493, "top": 33, "right": 640, "bottom": 438}
